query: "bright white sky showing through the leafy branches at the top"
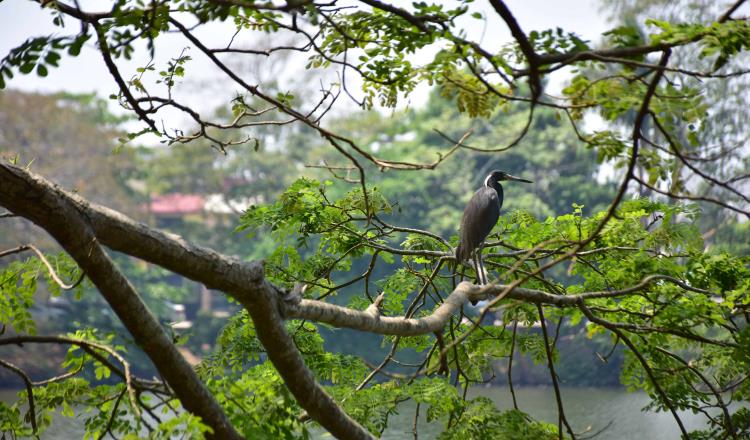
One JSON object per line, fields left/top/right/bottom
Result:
{"left": 0, "top": 0, "right": 609, "bottom": 131}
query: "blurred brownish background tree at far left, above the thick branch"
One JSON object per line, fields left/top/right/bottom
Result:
{"left": 0, "top": 91, "right": 137, "bottom": 248}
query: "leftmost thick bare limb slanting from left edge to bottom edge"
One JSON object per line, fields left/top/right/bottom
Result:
{"left": 0, "top": 165, "right": 241, "bottom": 439}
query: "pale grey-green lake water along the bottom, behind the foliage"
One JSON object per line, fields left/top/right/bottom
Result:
{"left": 0, "top": 387, "right": 724, "bottom": 440}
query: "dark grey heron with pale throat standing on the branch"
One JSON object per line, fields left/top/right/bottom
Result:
{"left": 456, "top": 170, "right": 532, "bottom": 284}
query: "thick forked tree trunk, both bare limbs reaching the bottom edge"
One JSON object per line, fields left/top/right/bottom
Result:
{"left": 0, "top": 164, "right": 371, "bottom": 439}
